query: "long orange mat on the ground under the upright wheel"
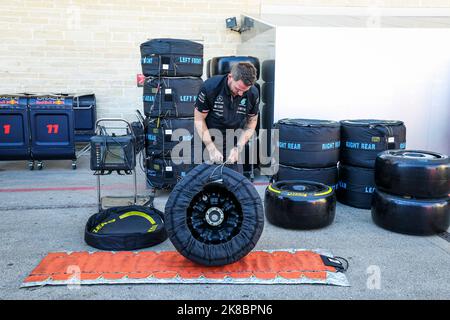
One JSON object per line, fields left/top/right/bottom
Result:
{"left": 22, "top": 250, "right": 348, "bottom": 287}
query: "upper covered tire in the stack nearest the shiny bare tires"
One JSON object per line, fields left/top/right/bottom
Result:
{"left": 340, "top": 119, "right": 406, "bottom": 168}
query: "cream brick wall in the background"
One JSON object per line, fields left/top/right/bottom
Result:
{"left": 0, "top": 0, "right": 450, "bottom": 118}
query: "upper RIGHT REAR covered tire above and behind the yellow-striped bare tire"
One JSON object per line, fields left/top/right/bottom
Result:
{"left": 274, "top": 119, "right": 340, "bottom": 168}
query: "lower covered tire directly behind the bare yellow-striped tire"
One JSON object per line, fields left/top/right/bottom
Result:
{"left": 272, "top": 164, "right": 338, "bottom": 189}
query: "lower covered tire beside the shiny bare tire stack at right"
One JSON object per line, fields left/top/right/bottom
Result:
{"left": 336, "top": 163, "right": 375, "bottom": 209}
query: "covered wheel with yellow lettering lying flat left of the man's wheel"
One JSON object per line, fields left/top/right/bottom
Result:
{"left": 84, "top": 205, "right": 167, "bottom": 251}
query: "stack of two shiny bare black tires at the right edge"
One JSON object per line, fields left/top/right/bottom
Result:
{"left": 372, "top": 150, "right": 450, "bottom": 235}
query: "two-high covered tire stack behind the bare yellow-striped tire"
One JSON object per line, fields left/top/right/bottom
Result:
{"left": 272, "top": 119, "right": 340, "bottom": 189}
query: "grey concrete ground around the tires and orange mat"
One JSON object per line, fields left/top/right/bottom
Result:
{"left": 0, "top": 156, "right": 450, "bottom": 300}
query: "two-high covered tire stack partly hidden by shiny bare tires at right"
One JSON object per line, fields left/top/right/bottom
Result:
{"left": 336, "top": 120, "right": 406, "bottom": 209}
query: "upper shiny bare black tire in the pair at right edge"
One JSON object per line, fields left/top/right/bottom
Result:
{"left": 375, "top": 150, "right": 450, "bottom": 199}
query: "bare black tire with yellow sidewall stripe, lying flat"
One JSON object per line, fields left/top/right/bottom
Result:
{"left": 264, "top": 180, "right": 336, "bottom": 230}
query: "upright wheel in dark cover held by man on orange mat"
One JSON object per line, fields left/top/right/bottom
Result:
{"left": 165, "top": 163, "right": 264, "bottom": 266}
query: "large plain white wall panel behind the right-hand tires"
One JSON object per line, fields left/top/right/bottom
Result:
{"left": 275, "top": 27, "right": 450, "bottom": 154}
